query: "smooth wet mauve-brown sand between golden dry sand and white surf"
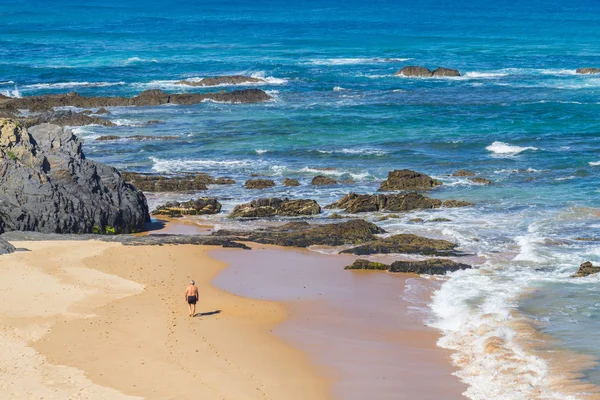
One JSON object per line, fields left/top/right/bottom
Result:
{"left": 210, "top": 245, "right": 467, "bottom": 400}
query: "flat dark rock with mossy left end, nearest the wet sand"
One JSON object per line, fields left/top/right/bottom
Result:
{"left": 344, "top": 258, "right": 471, "bottom": 275}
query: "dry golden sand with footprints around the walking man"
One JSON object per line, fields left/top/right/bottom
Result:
{"left": 0, "top": 241, "right": 331, "bottom": 400}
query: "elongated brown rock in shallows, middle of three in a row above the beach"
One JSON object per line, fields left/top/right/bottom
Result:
{"left": 229, "top": 198, "right": 321, "bottom": 218}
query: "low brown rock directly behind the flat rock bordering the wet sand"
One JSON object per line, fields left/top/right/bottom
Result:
{"left": 342, "top": 233, "right": 459, "bottom": 255}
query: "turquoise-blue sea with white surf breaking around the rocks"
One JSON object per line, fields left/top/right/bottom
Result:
{"left": 0, "top": 0, "right": 600, "bottom": 399}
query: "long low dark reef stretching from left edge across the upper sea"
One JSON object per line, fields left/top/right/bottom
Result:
{"left": 0, "top": 89, "right": 271, "bottom": 112}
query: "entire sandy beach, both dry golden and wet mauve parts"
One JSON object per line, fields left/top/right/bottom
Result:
{"left": 0, "top": 236, "right": 464, "bottom": 399}
